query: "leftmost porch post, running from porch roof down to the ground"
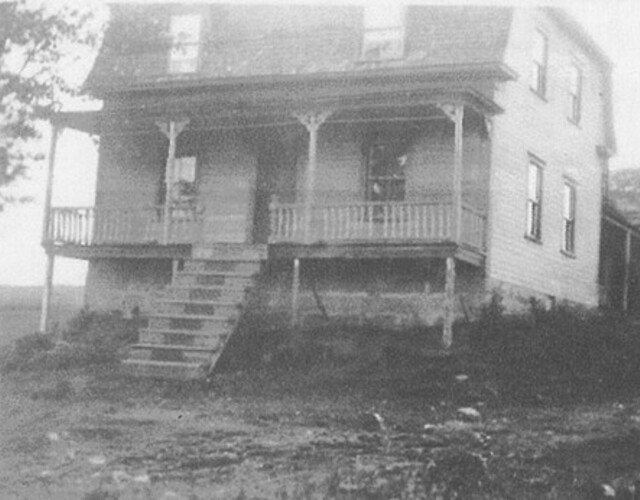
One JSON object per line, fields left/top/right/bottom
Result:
{"left": 39, "top": 125, "right": 61, "bottom": 333}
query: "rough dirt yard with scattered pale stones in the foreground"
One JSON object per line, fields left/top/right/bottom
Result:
{"left": 0, "top": 364, "right": 640, "bottom": 500}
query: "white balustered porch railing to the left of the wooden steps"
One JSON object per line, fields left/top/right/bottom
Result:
{"left": 45, "top": 206, "right": 201, "bottom": 245}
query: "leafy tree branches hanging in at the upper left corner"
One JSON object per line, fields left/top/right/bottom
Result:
{"left": 0, "top": 0, "right": 102, "bottom": 210}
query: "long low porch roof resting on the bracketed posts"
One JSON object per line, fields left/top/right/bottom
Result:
{"left": 52, "top": 88, "right": 503, "bottom": 135}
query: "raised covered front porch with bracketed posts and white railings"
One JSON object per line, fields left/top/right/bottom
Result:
{"left": 43, "top": 82, "right": 500, "bottom": 345}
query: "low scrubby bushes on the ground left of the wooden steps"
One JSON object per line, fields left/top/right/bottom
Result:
{"left": 0, "top": 310, "right": 140, "bottom": 372}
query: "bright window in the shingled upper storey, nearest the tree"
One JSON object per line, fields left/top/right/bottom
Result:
{"left": 169, "top": 14, "right": 201, "bottom": 73}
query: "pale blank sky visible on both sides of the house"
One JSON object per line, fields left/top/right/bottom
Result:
{"left": 0, "top": 0, "right": 640, "bottom": 285}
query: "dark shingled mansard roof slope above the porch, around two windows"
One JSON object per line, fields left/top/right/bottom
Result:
{"left": 86, "top": 4, "right": 512, "bottom": 95}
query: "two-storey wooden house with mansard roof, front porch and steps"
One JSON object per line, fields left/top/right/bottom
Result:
{"left": 44, "top": 4, "right": 615, "bottom": 374}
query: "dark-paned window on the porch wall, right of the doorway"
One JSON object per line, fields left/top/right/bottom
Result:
{"left": 366, "top": 140, "right": 407, "bottom": 202}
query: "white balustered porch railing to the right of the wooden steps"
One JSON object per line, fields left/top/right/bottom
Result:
{"left": 269, "top": 201, "right": 486, "bottom": 250}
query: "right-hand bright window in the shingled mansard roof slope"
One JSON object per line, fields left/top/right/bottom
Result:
{"left": 362, "top": 3, "right": 405, "bottom": 61}
